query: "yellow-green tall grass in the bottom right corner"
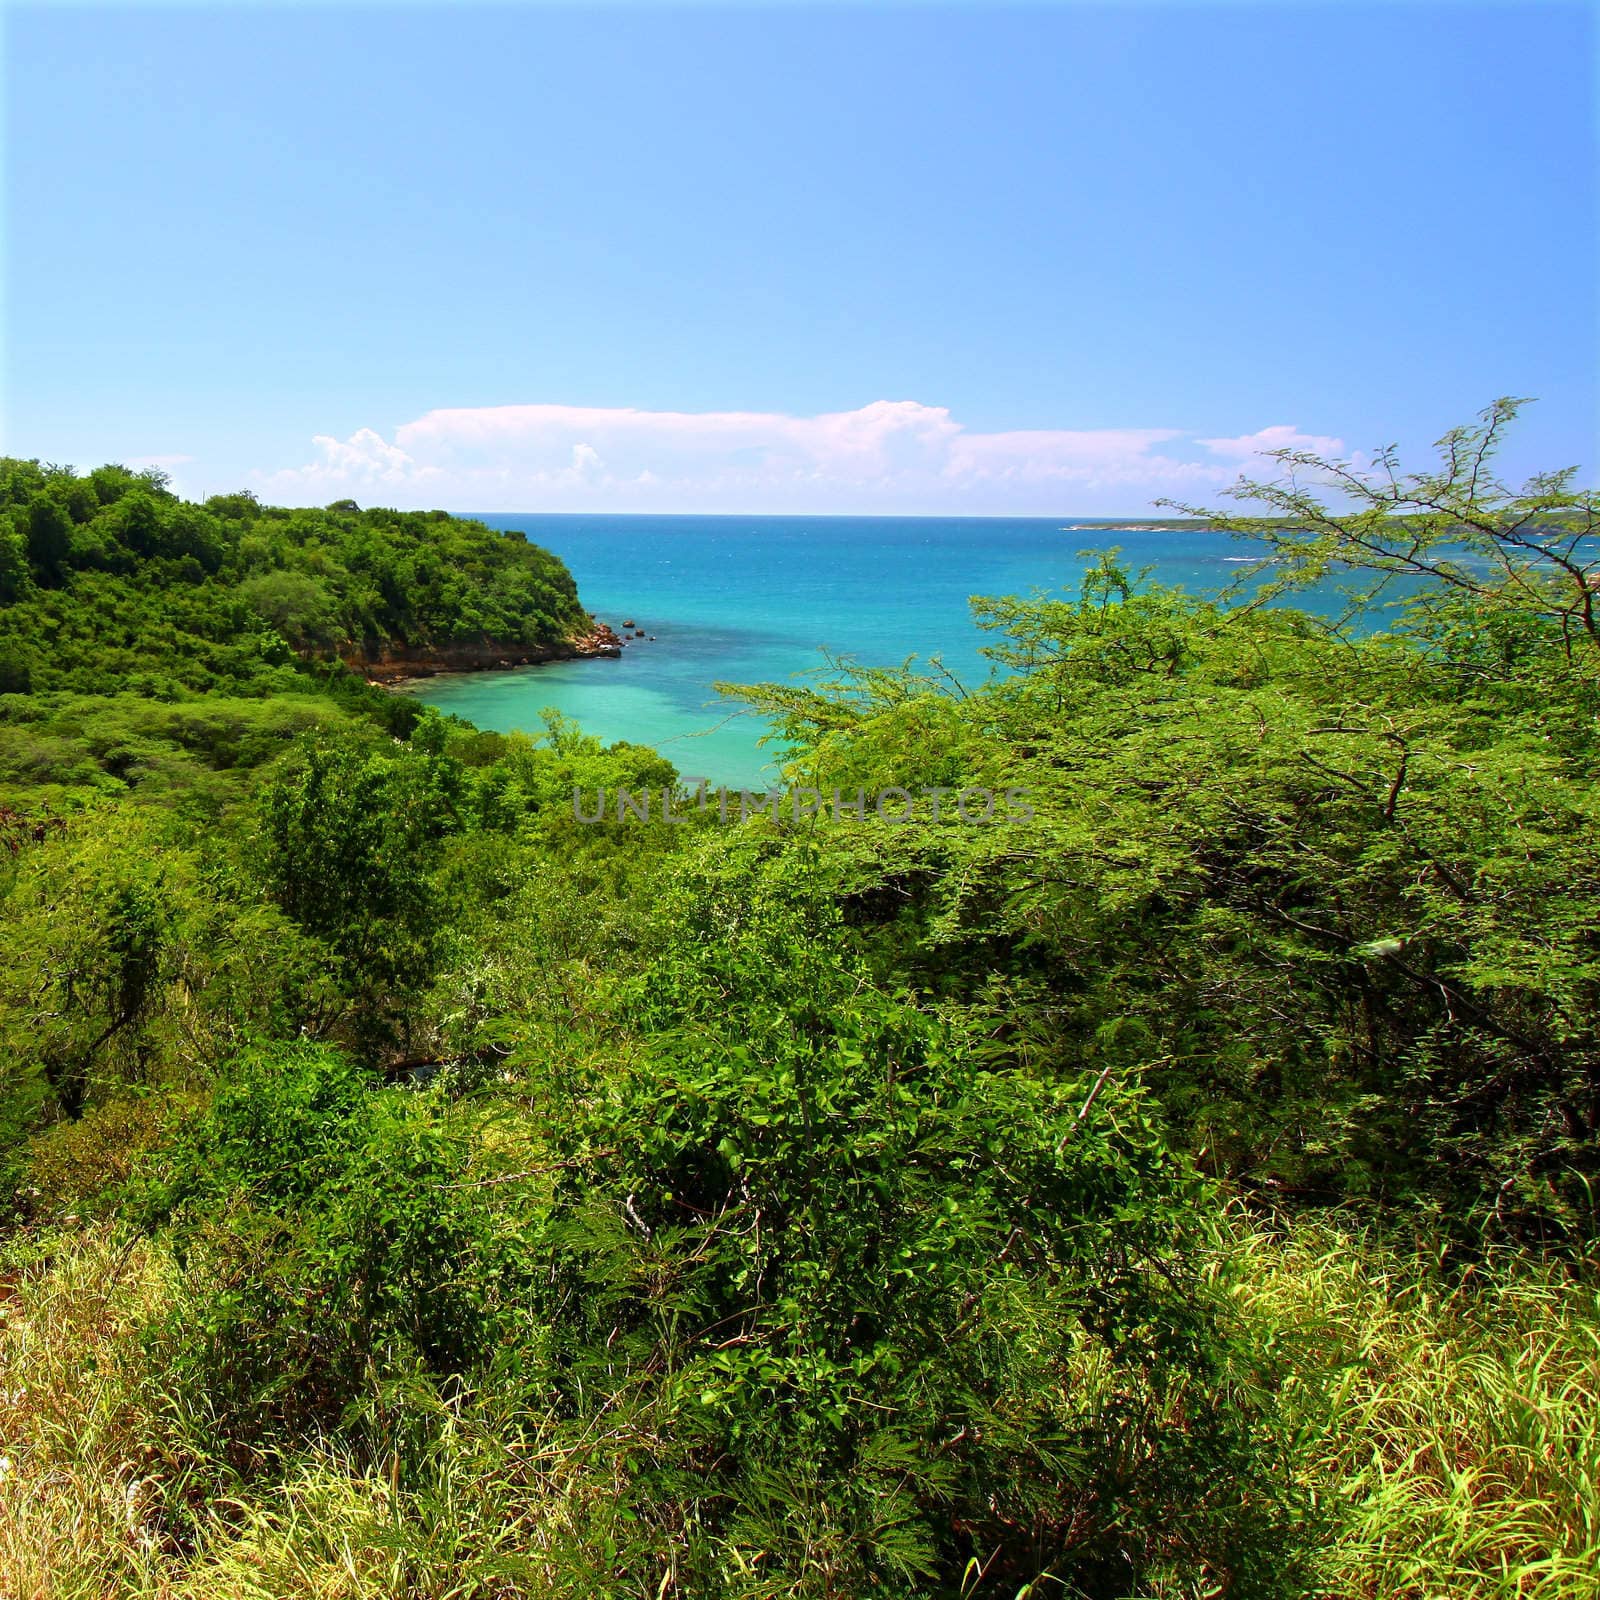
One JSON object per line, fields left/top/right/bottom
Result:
{"left": 1240, "top": 1224, "right": 1600, "bottom": 1600}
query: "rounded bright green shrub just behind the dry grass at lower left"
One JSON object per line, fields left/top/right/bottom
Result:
{"left": 139, "top": 1046, "right": 518, "bottom": 1443}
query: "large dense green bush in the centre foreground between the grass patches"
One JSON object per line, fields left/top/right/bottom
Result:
{"left": 515, "top": 864, "right": 1299, "bottom": 1595}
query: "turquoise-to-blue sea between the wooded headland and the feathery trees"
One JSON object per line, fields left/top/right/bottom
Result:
{"left": 406, "top": 514, "right": 1331, "bottom": 787}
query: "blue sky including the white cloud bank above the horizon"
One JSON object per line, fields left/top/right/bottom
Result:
{"left": 5, "top": 3, "right": 1600, "bottom": 515}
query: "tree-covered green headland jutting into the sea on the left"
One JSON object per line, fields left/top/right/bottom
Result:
{"left": 0, "top": 458, "right": 589, "bottom": 699}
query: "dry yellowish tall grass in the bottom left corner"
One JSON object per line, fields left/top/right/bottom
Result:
{"left": 0, "top": 1224, "right": 627, "bottom": 1600}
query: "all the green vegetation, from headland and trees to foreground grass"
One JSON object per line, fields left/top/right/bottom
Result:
{"left": 0, "top": 406, "right": 1600, "bottom": 1600}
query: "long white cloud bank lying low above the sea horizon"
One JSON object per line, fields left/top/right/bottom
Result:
{"left": 254, "top": 400, "right": 1339, "bottom": 514}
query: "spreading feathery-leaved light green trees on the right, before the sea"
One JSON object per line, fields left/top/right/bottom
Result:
{"left": 732, "top": 524, "right": 1600, "bottom": 1243}
